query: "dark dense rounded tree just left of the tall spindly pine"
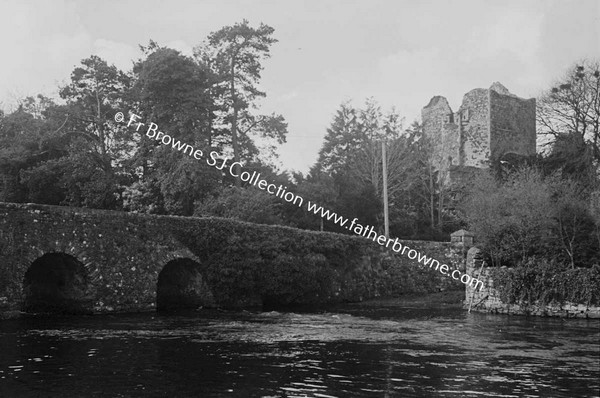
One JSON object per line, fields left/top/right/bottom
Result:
{"left": 124, "top": 46, "right": 219, "bottom": 215}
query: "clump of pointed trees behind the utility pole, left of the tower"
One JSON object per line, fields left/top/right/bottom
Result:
{"left": 299, "top": 99, "right": 459, "bottom": 240}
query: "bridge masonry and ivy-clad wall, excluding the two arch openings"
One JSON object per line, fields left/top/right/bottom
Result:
{"left": 0, "top": 203, "right": 465, "bottom": 318}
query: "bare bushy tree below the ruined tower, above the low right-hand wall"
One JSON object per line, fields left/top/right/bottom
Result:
{"left": 464, "top": 167, "right": 600, "bottom": 267}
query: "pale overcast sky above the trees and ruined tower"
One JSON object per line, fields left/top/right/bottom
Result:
{"left": 0, "top": 0, "right": 600, "bottom": 172}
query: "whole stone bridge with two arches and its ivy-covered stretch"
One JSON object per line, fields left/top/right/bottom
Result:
{"left": 0, "top": 202, "right": 461, "bottom": 316}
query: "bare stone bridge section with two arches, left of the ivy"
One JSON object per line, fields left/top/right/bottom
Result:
{"left": 0, "top": 203, "right": 217, "bottom": 318}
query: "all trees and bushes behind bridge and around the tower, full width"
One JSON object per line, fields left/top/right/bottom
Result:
{"left": 0, "top": 21, "right": 600, "bottom": 274}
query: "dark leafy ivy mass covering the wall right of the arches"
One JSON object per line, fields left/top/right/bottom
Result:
{"left": 174, "top": 218, "right": 377, "bottom": 307}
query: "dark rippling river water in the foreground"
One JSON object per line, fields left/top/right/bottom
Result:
{"left": 0, "top": 304, "right": 600, "bottom": 398}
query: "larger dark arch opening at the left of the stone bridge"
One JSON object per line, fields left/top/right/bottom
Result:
{"left": 23, "top": 252, "right": 93, "bottom": 314}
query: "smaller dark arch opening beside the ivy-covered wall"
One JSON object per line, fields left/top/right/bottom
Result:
{"left": 156, "top": 257, "right": 215, "bottom": 311}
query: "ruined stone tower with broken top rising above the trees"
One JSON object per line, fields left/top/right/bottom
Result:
{"left": 421, "top": 82, "right": 536, "bottom": 181}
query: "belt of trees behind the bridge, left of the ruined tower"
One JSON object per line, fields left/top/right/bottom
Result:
{"left": 0, "top": 38, "right": 458, "bottom": 240}
